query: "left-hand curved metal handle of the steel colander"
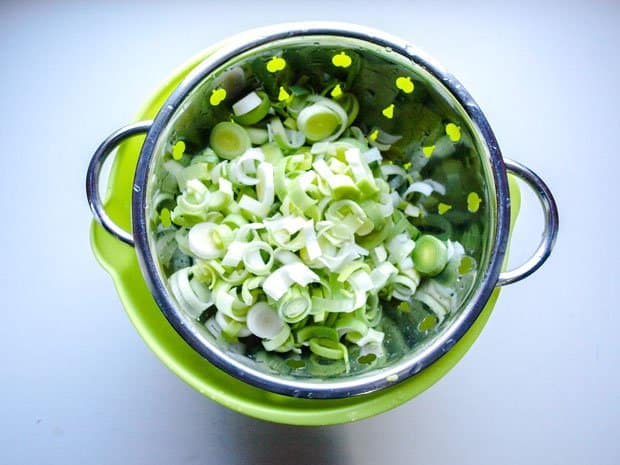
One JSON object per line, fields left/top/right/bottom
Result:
{"left": 86, "top": 121, "right": 153, "bottom": 247}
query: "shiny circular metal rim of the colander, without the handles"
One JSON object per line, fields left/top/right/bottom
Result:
{"left": 131, "top": 22, "right": 510, "bottom": 399}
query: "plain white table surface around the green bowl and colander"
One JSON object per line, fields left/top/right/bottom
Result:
{"left": 0, "top": 0, "right": 620, "bottom": 465}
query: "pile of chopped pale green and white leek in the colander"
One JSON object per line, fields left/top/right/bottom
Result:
{"left": 155, "top": 86, "right": 464, "bottom": 372}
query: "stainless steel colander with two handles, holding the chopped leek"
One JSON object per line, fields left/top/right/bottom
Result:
{"left": 87, "top": 23, "right": 558, "bottom": 398}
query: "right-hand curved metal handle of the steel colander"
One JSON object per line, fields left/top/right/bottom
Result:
{"left": 497, "top": 158, "right": 559, "bottom": 286}
